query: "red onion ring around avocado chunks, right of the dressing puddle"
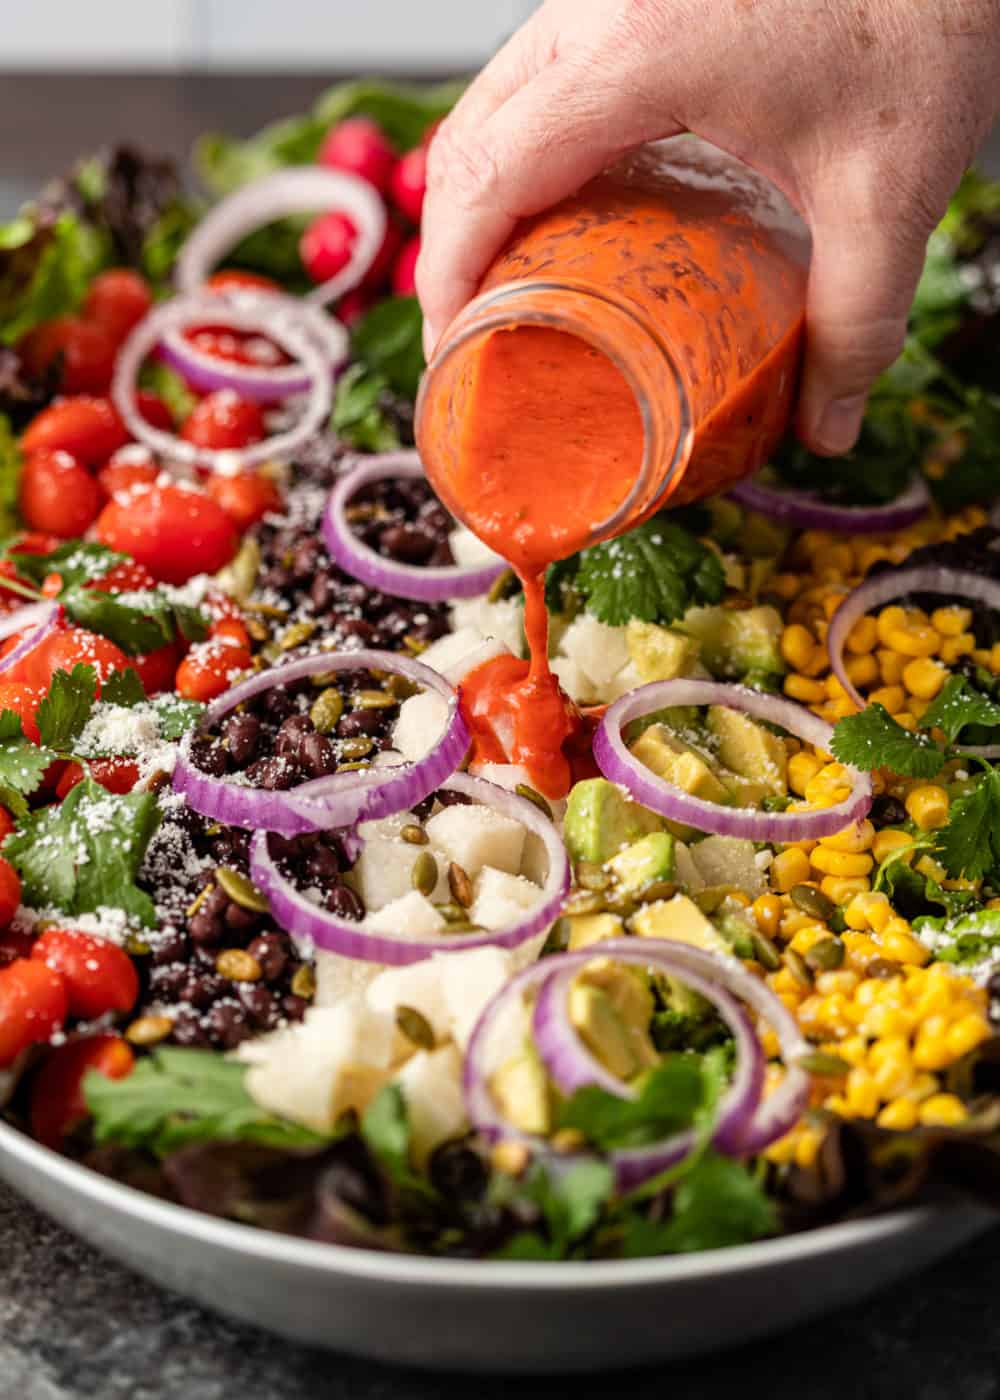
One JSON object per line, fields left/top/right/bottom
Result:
{"left": 594, "top": 680, "right": 871, "bottom": 841}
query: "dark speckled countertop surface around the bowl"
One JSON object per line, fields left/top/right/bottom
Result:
{"left": 0, "top": 73, "right": 1000, "bottom": 1400}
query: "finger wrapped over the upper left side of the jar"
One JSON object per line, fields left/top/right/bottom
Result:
{"left": 416, "top": 55, "right": 679, "bottom": 353}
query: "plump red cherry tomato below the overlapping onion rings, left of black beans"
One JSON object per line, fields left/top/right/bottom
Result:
{"left": 97, "top": 483, "right": 238, "bottom": 584}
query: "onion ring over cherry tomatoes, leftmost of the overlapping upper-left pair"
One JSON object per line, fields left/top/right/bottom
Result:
{"left": 111, "top": 293, "right": 332, "bottom": 473}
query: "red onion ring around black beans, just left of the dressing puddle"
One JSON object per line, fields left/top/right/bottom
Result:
{"left": 174, "top": 651, "right": 469, "bottom": 836}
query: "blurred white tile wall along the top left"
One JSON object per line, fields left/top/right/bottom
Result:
{"left": 0, "top": 0, "right": 540, "bottom": 73}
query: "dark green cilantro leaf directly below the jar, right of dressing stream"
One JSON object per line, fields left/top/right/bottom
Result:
{"left": 574, "top": 515, "right": 725, "bottom": 627}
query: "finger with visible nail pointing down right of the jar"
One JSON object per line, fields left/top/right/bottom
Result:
{"left": 797, "top": 186, "right": 933, "bottom": 456}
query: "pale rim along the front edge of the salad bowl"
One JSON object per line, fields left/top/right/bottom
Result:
{"left": 0, "top": 1121, "right": 948, "bottom": 1292}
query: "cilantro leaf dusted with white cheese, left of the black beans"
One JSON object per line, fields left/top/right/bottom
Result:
{"left": 4, "top": 778, "right": 160, "bottom": 927}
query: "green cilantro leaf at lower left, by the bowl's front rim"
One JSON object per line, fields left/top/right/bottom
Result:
{"left": 84, "top": 1049, "right": 329, "bottom": 1156}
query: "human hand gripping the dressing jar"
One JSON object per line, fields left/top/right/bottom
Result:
{"left": 416, "top": 0, "right": 1000, "bottom": 455}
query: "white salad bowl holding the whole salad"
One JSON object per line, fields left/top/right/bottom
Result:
{"left": 0, "top": 1124, "right": 996, "bottom": 1372}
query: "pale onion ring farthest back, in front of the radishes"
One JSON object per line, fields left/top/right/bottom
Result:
{"left": 175, "top": 165, "right": 385, "bottom": 307}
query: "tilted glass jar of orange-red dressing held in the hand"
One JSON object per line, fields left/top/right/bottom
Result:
{"left": 416, "top": 137, "right": 810, "bottom": 574}
